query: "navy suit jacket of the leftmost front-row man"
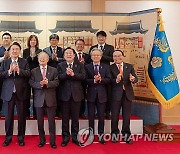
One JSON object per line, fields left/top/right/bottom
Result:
{"left": 0, "top": 57, "right": 30, "bottom": 101}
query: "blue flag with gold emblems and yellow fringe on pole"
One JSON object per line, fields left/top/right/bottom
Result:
{"left": 147, "top": 9, "right": 180, "bottom": 109}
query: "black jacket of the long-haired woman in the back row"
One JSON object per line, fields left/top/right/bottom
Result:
{"left": 23, "top": 48, "right": 42, "bottom": 70}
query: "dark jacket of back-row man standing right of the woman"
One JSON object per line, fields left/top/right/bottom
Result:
{"left": 43, "top": 47, "right": 64, "bottom": 68}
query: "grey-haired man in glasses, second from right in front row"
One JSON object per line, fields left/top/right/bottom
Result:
{"left": 85, "top": 48, "right": 111, "bottom": 144}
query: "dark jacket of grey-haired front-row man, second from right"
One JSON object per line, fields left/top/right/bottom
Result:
{"left": 85, "top": 63, "right": 111, "bottom": 103}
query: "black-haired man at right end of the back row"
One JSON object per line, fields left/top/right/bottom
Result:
{"left": 89, "top": 31, "right": 114, "bottom": 119}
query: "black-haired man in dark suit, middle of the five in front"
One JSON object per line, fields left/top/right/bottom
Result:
{"left": 58, "top": 47, "right": 86, "bottom": 147}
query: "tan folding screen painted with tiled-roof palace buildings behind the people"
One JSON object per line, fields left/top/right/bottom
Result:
{"left": 0, "top": 9, "right": 157, "bottom": 123}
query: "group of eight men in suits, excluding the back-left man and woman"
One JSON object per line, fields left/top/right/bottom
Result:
{"left": 0, "top": 31, "right": 137, "bottom": 148}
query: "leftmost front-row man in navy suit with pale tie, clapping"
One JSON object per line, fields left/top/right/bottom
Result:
{"left": 0, "top": 42, "right": 30, "bottom": 146}
